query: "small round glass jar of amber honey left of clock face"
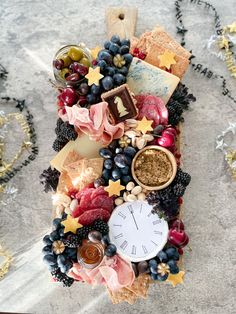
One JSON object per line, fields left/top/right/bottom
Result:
{"left": 78, "top": 240, "right": 104, "bottom": 269}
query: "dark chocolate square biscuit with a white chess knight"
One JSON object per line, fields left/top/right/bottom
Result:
{"left": 102, "top": 84, "right": 138, "bottom": 124}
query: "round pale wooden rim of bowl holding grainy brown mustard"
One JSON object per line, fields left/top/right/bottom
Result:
{"left": 131, "top": 145, "right": 177, "bottom": 191}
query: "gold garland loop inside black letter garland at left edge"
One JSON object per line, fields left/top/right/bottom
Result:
{"left": 0, "top": 113, "right": 32, "bottom": 192}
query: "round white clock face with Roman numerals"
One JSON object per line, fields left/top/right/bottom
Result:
{"left": 108, "top": 201, "right": 169, "bottom": 262}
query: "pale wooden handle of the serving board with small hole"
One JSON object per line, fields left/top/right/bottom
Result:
{"left": 106, "top": 7, "right": 138, "bottom": 39}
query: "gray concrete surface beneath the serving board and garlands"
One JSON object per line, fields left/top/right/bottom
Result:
{"left": 0, "top": 0, "right": 236, "bottom": 314}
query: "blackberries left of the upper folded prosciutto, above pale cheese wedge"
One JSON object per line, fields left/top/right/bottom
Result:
{"left": 52, "top": 118, "right": 78, "bottom": 152}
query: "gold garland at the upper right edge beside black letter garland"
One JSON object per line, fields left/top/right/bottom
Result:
{"left": 218, "top": 22, "right": 236, "bottom": 78}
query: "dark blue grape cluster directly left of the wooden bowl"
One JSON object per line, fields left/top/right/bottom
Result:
{"left": 95, "top": 141, "right": 137, "bottom": 185}
